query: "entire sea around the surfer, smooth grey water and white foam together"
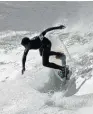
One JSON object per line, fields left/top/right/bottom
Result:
{"left": 0, "top": 2, "right": 93, "bottom": 114}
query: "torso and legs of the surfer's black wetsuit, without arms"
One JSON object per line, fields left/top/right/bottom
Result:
{"left": 30, "top": 36, "right": 62, "bottom": 70}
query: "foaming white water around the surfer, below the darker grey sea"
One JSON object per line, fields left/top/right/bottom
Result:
{"left": 0, "top": 2, "right": 93, "bottom": 114}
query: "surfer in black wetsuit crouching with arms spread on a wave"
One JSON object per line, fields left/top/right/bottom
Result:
{"left": 21, "top": 25, "right": 69, "bottom": 74}
